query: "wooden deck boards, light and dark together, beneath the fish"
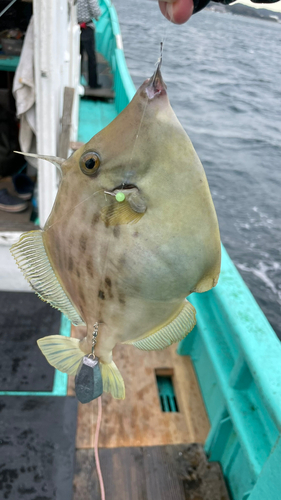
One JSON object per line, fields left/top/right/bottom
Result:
{"left": 68, "top": 328, "right": 228, "bottom": 500}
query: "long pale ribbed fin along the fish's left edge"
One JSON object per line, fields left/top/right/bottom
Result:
{"left": 10, "top": 230, "right": 84, "bottom": 325}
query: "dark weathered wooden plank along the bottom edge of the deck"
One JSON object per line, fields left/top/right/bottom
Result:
{"left": 73, "top": 444, "right": 229, "bottom": 500}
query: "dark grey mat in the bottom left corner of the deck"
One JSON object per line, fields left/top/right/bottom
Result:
{"left": 0, "top": 396, "right": 77, "bottom": 500}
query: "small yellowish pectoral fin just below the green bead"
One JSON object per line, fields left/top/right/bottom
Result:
{"left": 101, "top": 200, "right": 144, "bottom": 226}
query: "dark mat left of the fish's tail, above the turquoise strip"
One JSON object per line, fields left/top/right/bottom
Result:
{"left": 0, "top": 292, "right": 61, "bottom": 392}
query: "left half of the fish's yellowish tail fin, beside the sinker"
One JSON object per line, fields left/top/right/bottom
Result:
{"left": 37, "top": 335, "right": 85, "bottom": 375}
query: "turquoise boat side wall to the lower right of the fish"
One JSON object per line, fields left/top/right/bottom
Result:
{"left": 178, "top": 243, "right": 281, "bottom": 500}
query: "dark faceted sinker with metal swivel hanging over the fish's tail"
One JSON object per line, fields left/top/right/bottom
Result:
{"left": 75, "top": 323, "right": 103, "bottom": 403}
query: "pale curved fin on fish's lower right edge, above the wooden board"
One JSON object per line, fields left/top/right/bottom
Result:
{"left": 132, "top": 300, "right": 196, "bottom": 351}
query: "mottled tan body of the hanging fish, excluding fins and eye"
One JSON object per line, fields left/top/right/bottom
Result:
{"left": 43, "top": 67, "right": 220, "bottom": 363}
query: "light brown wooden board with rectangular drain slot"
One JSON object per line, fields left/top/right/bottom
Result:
{"left": 68, "top": 327, "right": 209, "bottom": 449}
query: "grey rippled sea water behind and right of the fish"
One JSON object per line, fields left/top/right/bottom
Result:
{"left": 114, "top": 0, "right": 281, "bottom": 339}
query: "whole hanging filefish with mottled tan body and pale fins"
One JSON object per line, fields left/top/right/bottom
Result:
{"left": 11, "top": 65, "right": 220, "bottom": 399}
